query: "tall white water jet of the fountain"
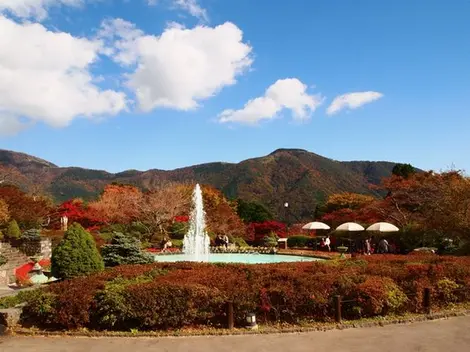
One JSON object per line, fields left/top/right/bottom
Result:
{"left": 183, "top": 184, "right": 210, "bottom": 262}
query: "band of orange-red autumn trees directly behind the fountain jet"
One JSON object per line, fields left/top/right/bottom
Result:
{"left": 55, "top": 183, "right": 245, "bottom": 238}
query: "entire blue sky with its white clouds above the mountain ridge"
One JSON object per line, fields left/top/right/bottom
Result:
{"left": 0, "top": 0, "right": 470, "bottom": 171}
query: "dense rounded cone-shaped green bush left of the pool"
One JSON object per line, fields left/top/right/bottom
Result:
{"left": 51, "top": 223, "right": 104, "bottom": 279}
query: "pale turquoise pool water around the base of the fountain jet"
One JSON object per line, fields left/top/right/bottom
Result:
{"left": 155, "top": 253, "right": 323, "bottom": 264}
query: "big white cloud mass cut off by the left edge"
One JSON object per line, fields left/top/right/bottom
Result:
{"left": 0, "top": 15, "right": 126, "bottom": 133}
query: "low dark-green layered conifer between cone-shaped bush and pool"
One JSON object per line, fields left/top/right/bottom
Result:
{"left": 101, "top": 232, "right": 154, "bottom": 266}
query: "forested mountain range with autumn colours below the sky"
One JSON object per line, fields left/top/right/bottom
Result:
{"left": 0, "top": 149, "right": 404, "bottom": 220}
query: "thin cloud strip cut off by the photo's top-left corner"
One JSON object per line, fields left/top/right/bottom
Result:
{"left": 0, "top": 0, "right": 84, "bottom": 20}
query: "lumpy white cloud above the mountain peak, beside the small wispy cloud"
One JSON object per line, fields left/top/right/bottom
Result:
{"left": 218, "top": 78, "right": 323, "bottom": 124}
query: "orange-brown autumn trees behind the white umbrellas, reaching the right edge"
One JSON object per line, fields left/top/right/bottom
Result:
{"left": 322, "top": 171, "right": 470, "bottom": 242}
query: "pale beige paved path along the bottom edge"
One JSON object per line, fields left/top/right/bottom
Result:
{"left": 0, "top": 317, "right": 470, "bottom": 352}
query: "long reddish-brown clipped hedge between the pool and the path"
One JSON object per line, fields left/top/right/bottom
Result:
{"left": 22, "top": 255, "right": 470, "bottom": 330}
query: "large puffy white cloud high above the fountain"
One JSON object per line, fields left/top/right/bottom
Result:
{"left": 99, "top": 19, "right": 252, "bottom": 111}
